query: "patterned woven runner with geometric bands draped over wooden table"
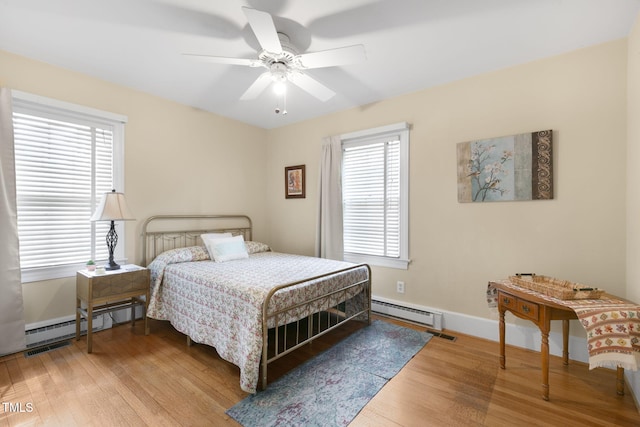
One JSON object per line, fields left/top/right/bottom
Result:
{"left": 487, "top": 280, "right": 640, "bottom": 371}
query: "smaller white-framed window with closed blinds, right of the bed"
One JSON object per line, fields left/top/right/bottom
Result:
{"left": 341, "top": 123, "right": 409, "bottom": 269}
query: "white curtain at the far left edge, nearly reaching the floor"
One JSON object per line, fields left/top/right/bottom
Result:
{"left": 0, "top": 87, "right": 26, "bottom": 355}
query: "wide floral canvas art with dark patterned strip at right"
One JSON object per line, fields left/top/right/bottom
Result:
{"left": 457, "top": 130, "right": 553, "bottom": 203}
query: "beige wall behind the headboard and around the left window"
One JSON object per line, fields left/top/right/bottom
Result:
{"left": 0, "top": 51, "right": 268, "bottom": 323}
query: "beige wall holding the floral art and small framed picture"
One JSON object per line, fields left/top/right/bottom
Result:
{"left": 267, "top": 40, "right": 627, "bottom": 317}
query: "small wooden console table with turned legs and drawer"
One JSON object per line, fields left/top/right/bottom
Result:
{"left": 490, "top": 282, "right": 624, "bottom": 400}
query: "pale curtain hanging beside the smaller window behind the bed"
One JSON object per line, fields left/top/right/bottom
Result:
{"left": 316, "top": 136, "right": 344, "bottom": 260}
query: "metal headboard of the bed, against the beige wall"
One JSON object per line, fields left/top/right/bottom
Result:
{"left": 142, "top": 215, "right": 252, "bottom": 266}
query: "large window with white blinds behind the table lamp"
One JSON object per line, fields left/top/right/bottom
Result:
{"left": 13, "top": 91, "right": 126, "bottom": 282}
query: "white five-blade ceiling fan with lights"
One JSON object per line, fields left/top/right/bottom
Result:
{"left": 184, "top": 6, "right": 366, "bottom": 102}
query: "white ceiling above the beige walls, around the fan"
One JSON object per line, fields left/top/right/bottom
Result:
{"left": 0, "top": 0, "right": 640, "bottom": 129}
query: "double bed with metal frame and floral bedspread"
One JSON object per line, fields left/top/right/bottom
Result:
{"left": 142, "top": 215, "right": 371, "bottom": 393}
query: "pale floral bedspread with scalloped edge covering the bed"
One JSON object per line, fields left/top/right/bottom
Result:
{"left": 148, "top": 246, "right": 368, "bottom": 393}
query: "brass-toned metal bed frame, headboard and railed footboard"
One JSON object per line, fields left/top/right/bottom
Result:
{"left": 142, "top": 215, "right": 371, "bottom": 389}
